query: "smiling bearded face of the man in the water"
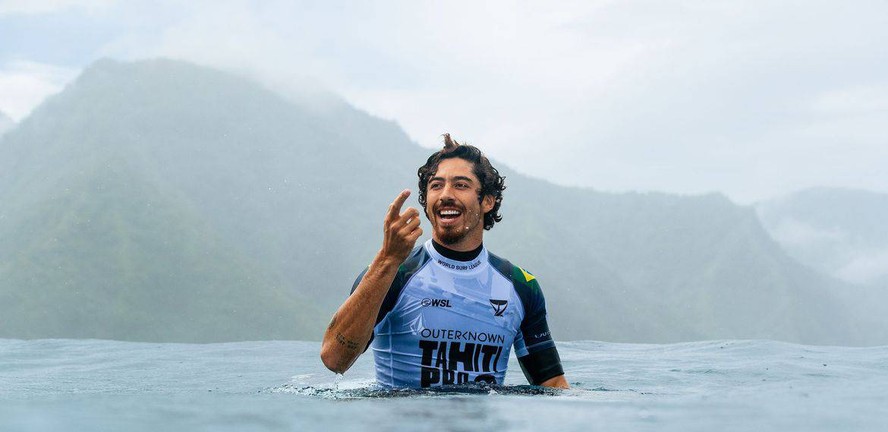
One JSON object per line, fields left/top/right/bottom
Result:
{"left": 426, "top": 158, "right": 494, "bottom": 250}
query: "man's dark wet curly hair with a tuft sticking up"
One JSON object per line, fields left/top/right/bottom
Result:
{"left": 416, "top": 133, "right": 506, "bottom": 230}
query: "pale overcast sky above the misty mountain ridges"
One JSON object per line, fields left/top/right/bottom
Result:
{"left": 0, "top": 0, "right": 888, "bottom": 203}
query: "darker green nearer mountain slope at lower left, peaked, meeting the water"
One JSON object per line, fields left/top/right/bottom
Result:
{"left": 0, "top": 159, "right": 316, "bottom": 341}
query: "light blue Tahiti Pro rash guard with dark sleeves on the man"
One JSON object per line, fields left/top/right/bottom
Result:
{"left": 352, "top": 240, "right": 564, "bottom": 388}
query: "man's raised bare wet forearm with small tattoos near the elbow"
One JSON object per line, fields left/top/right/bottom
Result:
{"left": 321, "top": 253, "right": 400, "bottom": 373}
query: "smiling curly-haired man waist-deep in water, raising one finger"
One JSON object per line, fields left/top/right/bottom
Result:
{"left": 321, "top": 134, "right": 568, "bottom": 388}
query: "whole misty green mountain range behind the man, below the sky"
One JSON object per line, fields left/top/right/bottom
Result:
{"left": 0, "top": 60, "right": 886, "bottom": 344}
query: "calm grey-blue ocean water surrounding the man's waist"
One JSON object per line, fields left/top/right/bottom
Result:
{"left": 0, "top": 340, "right": 888, "bottom": 432}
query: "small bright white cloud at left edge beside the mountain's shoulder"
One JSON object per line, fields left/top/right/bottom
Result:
{"left": 0, "top": 61, "right": 79, "bottom": 121}
